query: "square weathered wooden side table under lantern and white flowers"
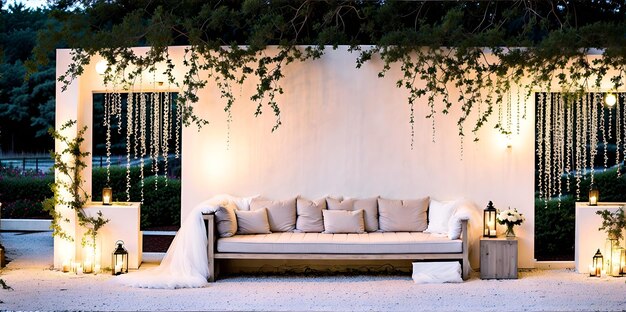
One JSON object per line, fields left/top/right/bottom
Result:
{"left": 480, "top": 237, "right": 517, "bottom": 279}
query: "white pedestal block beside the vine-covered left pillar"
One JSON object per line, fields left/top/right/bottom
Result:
{"left": 76, "top": 203, "right": 143, "bottom": 269}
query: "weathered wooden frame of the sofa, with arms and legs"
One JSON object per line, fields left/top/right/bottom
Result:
{"left": 203, "top": 214, "right": 470, "bottom": 282}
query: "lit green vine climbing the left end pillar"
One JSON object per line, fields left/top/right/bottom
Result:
{"left": 43, "top": 120, "right": 109, "bottom": 248}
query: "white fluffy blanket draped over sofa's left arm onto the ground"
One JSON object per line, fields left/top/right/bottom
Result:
{"left": 114, "top": 195, "right": 252, "bottom": 289}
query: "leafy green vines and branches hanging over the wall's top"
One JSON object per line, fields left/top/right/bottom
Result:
{"left": 29, "top": 0, "right": 626, "bottom": 144}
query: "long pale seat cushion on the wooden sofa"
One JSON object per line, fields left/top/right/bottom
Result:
{"left": 217, "top": 232, "right": 462, "bottom": 254}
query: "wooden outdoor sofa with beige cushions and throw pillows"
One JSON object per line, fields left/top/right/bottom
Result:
{"left": 204, "top": 197, "right": 470, "bottom": 282}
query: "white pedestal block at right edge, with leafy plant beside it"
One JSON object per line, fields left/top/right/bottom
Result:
{"left": 574, "top": 202, "right": 626, "bottom": 274}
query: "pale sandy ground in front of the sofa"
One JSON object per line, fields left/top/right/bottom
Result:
{"left": 0, "top": 233, "right": 626, "bottom": 311}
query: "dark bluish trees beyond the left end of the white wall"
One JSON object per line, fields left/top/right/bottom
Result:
{"left": 0, "top": 4, "right": 55, "bottom": 155}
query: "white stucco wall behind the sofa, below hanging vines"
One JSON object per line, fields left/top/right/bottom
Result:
{"left": 55, "top": 47, "right": 535, "bottom": 267}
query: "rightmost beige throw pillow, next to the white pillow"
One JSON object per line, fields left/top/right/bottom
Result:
{"left": 378, "top": 197, "right": 429, "bottom": 232}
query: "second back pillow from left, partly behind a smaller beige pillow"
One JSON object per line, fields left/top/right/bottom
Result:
{"left": 250, "top": 197, "right": 296, "bottom": 232}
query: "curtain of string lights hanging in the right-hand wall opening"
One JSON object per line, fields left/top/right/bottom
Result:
{"left": 535, "top": 92, "right": 626, "bottom": 205}
